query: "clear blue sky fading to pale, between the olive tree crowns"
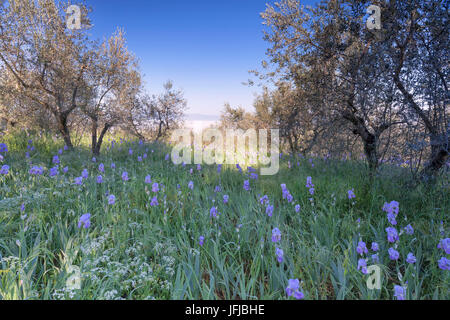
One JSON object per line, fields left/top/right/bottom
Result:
{"left": 87, "top": 0, "right": 315, "bottom": 115}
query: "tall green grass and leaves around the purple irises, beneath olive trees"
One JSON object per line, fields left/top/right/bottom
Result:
{"left": 0, "top": 132, "right": 450, "bottom": 299}
